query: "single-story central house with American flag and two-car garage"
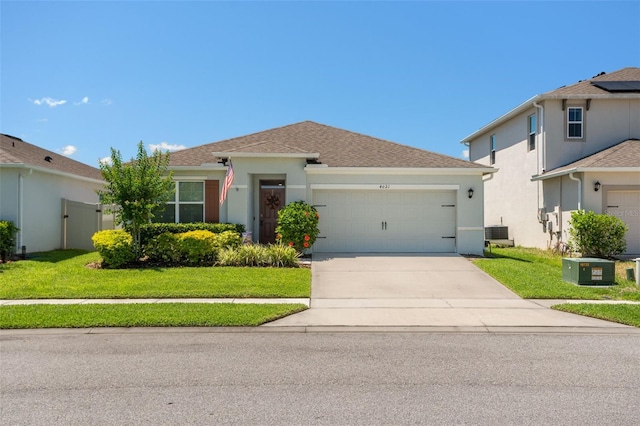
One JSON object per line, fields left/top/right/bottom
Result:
{"left": 165, "top": 121, "right": 495, "bottom": 254}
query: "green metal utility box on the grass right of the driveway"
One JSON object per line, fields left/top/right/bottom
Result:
{"left": 562, "top": 257, "right": 616, "bottom": 285}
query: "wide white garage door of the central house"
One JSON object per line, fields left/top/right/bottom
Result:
{"left": 313, "top": 190, "right": 456, "bottom": 253}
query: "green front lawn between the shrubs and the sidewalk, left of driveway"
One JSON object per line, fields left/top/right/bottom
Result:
{"left": 0, "top": 250, "right": 311, "bottom": 299}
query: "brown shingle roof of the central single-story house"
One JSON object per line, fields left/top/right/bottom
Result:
{"left": 169, "top": 121, "right": 486, "bottom": 168}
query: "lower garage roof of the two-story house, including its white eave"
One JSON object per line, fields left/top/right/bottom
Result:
{"left": 532, "top": 139, "right": 640, "bottom": 180}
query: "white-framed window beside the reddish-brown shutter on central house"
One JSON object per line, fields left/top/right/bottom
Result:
{"left": 154, "top": 182, "right": 204, "bottom": 223}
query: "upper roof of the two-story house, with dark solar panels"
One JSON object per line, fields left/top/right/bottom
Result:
{"left": 461, "top": 67, "right": 640, "bottom": 143}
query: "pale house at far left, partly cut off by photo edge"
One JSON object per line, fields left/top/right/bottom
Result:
{"left": 0, "top": 134, "right": 104, "bottom": 253}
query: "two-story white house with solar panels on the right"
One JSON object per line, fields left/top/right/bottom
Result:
{"left": 462, "top": 68, "right": 640, "bottom": 255}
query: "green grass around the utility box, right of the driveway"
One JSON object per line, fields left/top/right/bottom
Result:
{"left": 473, "top": 247, "right": 640, "bottom": 300}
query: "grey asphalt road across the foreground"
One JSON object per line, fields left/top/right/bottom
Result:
{"left": 0, "top": 330, "right": 640, "bottom": 425}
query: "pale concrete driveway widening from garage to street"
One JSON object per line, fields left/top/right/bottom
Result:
{"left": 265, "top": 253, "right": 638, "bottom": 332}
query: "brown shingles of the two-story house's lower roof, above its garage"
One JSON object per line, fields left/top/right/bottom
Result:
{"left": 542, "top": 139, "right": 640, "bottom": 176}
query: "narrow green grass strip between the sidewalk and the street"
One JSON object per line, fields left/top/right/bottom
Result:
{"left": 0, "top": 303, "right": 307, "bottom": 329}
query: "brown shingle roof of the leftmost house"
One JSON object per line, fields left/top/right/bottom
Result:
{"left": 0, "top": 133, "right": 102, "bottom": 180}
